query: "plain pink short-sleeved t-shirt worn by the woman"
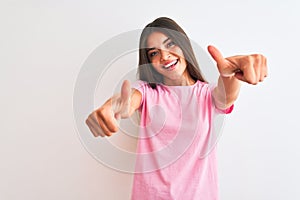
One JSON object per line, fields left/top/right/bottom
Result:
{"left": 132, "top": 81, "right": 233, "bottom": 200}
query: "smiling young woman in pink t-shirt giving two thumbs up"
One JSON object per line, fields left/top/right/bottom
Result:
{"left": 86, "top": 17, "right": 267, "bottom": 200}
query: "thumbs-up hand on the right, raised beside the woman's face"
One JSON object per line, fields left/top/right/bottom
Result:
{"left": 208, "top": 46, "right": 268, "bottom": 85}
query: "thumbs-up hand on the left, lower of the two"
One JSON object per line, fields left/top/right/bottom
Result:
{"left": 86, "top": 80, "right": 131, "bottom": 137}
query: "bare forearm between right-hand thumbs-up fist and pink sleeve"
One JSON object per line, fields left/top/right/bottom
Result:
{"left": 213, "top": 75, "right": 241, "bottom": 109}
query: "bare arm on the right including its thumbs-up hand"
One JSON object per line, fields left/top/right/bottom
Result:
{"left": 208, "top": 46, "right": 268, "bottom": 109}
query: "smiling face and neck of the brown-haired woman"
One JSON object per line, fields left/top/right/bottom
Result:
{"left": 147, "top": 32, "right": 189, "bottom": 85}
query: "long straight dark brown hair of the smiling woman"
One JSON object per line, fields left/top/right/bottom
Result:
{"left": 138, "top": 17, "right": 206, "bottom": 89}
